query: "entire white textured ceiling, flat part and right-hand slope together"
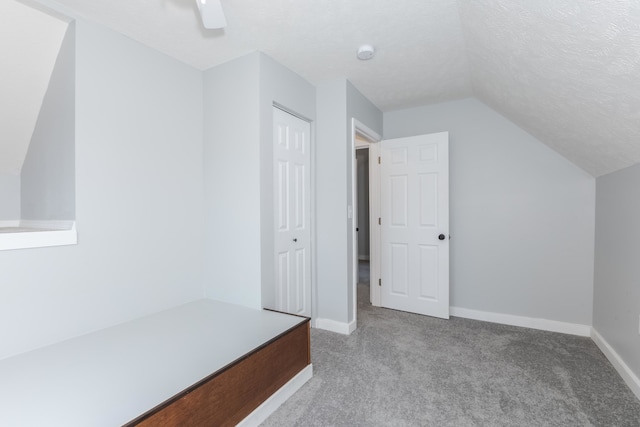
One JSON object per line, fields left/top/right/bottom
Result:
{"left": 26, "top": 0, "right": 640, "bottom": 176}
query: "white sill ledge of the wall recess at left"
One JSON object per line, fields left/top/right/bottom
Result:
{"left": 0, "top": 221, "right": 78, "bottom": 251}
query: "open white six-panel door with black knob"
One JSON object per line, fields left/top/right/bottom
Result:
{"left": 380, "top": 132, "right": 449, "bottom": 319}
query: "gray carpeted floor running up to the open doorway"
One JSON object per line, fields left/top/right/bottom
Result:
{"left": 262, "top": 262, "right": 640, "bottom": 427}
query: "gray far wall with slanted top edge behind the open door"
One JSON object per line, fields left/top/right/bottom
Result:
{"left": 384, "top": 99, "right": 596, "bottom": 325}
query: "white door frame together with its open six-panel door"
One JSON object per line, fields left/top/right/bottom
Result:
{"left": 352, "top": 125, "right": 449, "bottom": 326}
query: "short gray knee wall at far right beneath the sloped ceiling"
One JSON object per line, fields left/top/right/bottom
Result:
{"left": 593, "top": 165, "right": 640, "bottom": 377}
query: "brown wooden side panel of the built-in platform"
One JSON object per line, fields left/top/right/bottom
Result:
{"left": 129, "top": 321, "right": 310, "bottom": 427}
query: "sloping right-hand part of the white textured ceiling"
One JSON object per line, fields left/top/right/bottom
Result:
{"left": 460, "top": 0, "right": 640, "bottom": 176}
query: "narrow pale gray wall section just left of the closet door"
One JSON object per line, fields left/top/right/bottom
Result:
{"left": 204, "top": 54, "right": 262, "bottom": 308}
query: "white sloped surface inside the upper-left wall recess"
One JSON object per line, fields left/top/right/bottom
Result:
{"left": 0, "top": 0, "right": 68, "bottom": 175}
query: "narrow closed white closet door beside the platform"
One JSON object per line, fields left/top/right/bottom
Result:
{"left": 273, "top": 107, "right": 311, "bottom": 317}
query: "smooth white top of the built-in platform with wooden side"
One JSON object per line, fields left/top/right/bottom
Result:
{"left": 0, "top": 300, "right": 305, "bottom": 427}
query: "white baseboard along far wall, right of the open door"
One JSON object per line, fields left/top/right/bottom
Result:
{"left": 450, "top": 307, "right": 591, "bottom": 337}
